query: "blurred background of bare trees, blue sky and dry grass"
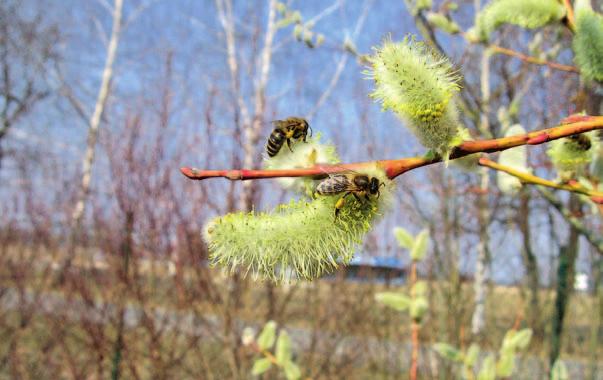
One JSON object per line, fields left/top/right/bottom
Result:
{"left": 0, "top": 0, "right": 603, "bottom": 379}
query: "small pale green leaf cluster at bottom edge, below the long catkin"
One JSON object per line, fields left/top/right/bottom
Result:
{"left": 243, "top": 321, "right": 301, "bottom": 380}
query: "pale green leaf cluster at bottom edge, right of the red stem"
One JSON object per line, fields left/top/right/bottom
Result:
{"left": 434, "top": 329, "right": 532, "bottom": 380}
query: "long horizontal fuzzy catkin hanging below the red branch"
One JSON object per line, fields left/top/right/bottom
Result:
{"left": 204, "top": 167, "right": 393, "bottom": 281}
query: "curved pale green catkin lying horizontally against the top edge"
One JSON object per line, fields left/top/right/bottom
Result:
{"left": 476, "top": 0, "right": 565, "bottom": 41}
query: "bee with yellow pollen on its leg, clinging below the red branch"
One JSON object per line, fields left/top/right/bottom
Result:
{"left": 316, "top": 171, "right": 385, "bottom": 219}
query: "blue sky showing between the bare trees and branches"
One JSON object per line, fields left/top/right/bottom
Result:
{"left": 0, "top": 0, "right": 587, "bottom": 281}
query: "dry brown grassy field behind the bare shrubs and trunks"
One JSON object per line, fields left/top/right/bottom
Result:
{"left": 0, "top": 245, "right": 603, "bottom": 378}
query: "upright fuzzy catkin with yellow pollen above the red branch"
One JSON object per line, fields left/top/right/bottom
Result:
{"left": 368, "top": 37, "right": 460, "bottom": 157}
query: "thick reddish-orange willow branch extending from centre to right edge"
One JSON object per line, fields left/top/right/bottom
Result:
{"left": 180, "top": 115, "right": 603, "bottom": 181}
